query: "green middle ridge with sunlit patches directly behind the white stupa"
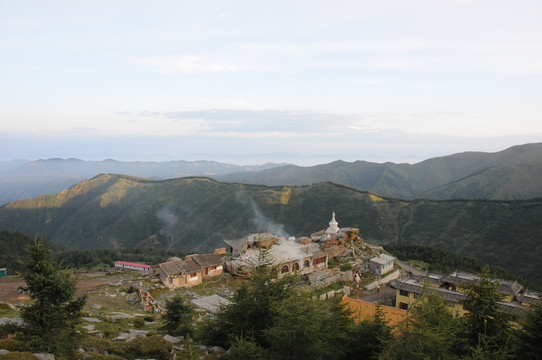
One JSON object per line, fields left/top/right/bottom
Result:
{"left": 0, "top": 174, "right": 542, "bottom": 279}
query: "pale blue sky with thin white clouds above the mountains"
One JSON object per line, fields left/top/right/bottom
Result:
{"left": 0, "top": 0, "right": 542, "bottom": 165}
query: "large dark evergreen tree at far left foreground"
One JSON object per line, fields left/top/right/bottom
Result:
{"left": 20, "top": 240, "right": 86, "bottom": 352}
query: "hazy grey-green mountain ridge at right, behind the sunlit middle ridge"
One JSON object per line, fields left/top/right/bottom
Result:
{"left": 217, "top": 143, "right": 542, "bottom": 200}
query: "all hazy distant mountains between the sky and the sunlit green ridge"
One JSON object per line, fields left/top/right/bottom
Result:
{"left": 0, "top": 143, "right": 542, "bottom": 204}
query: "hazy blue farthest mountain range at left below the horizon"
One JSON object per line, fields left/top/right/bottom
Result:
{"left": 0, "top": 159, "right": 282, "bottom": 204}
